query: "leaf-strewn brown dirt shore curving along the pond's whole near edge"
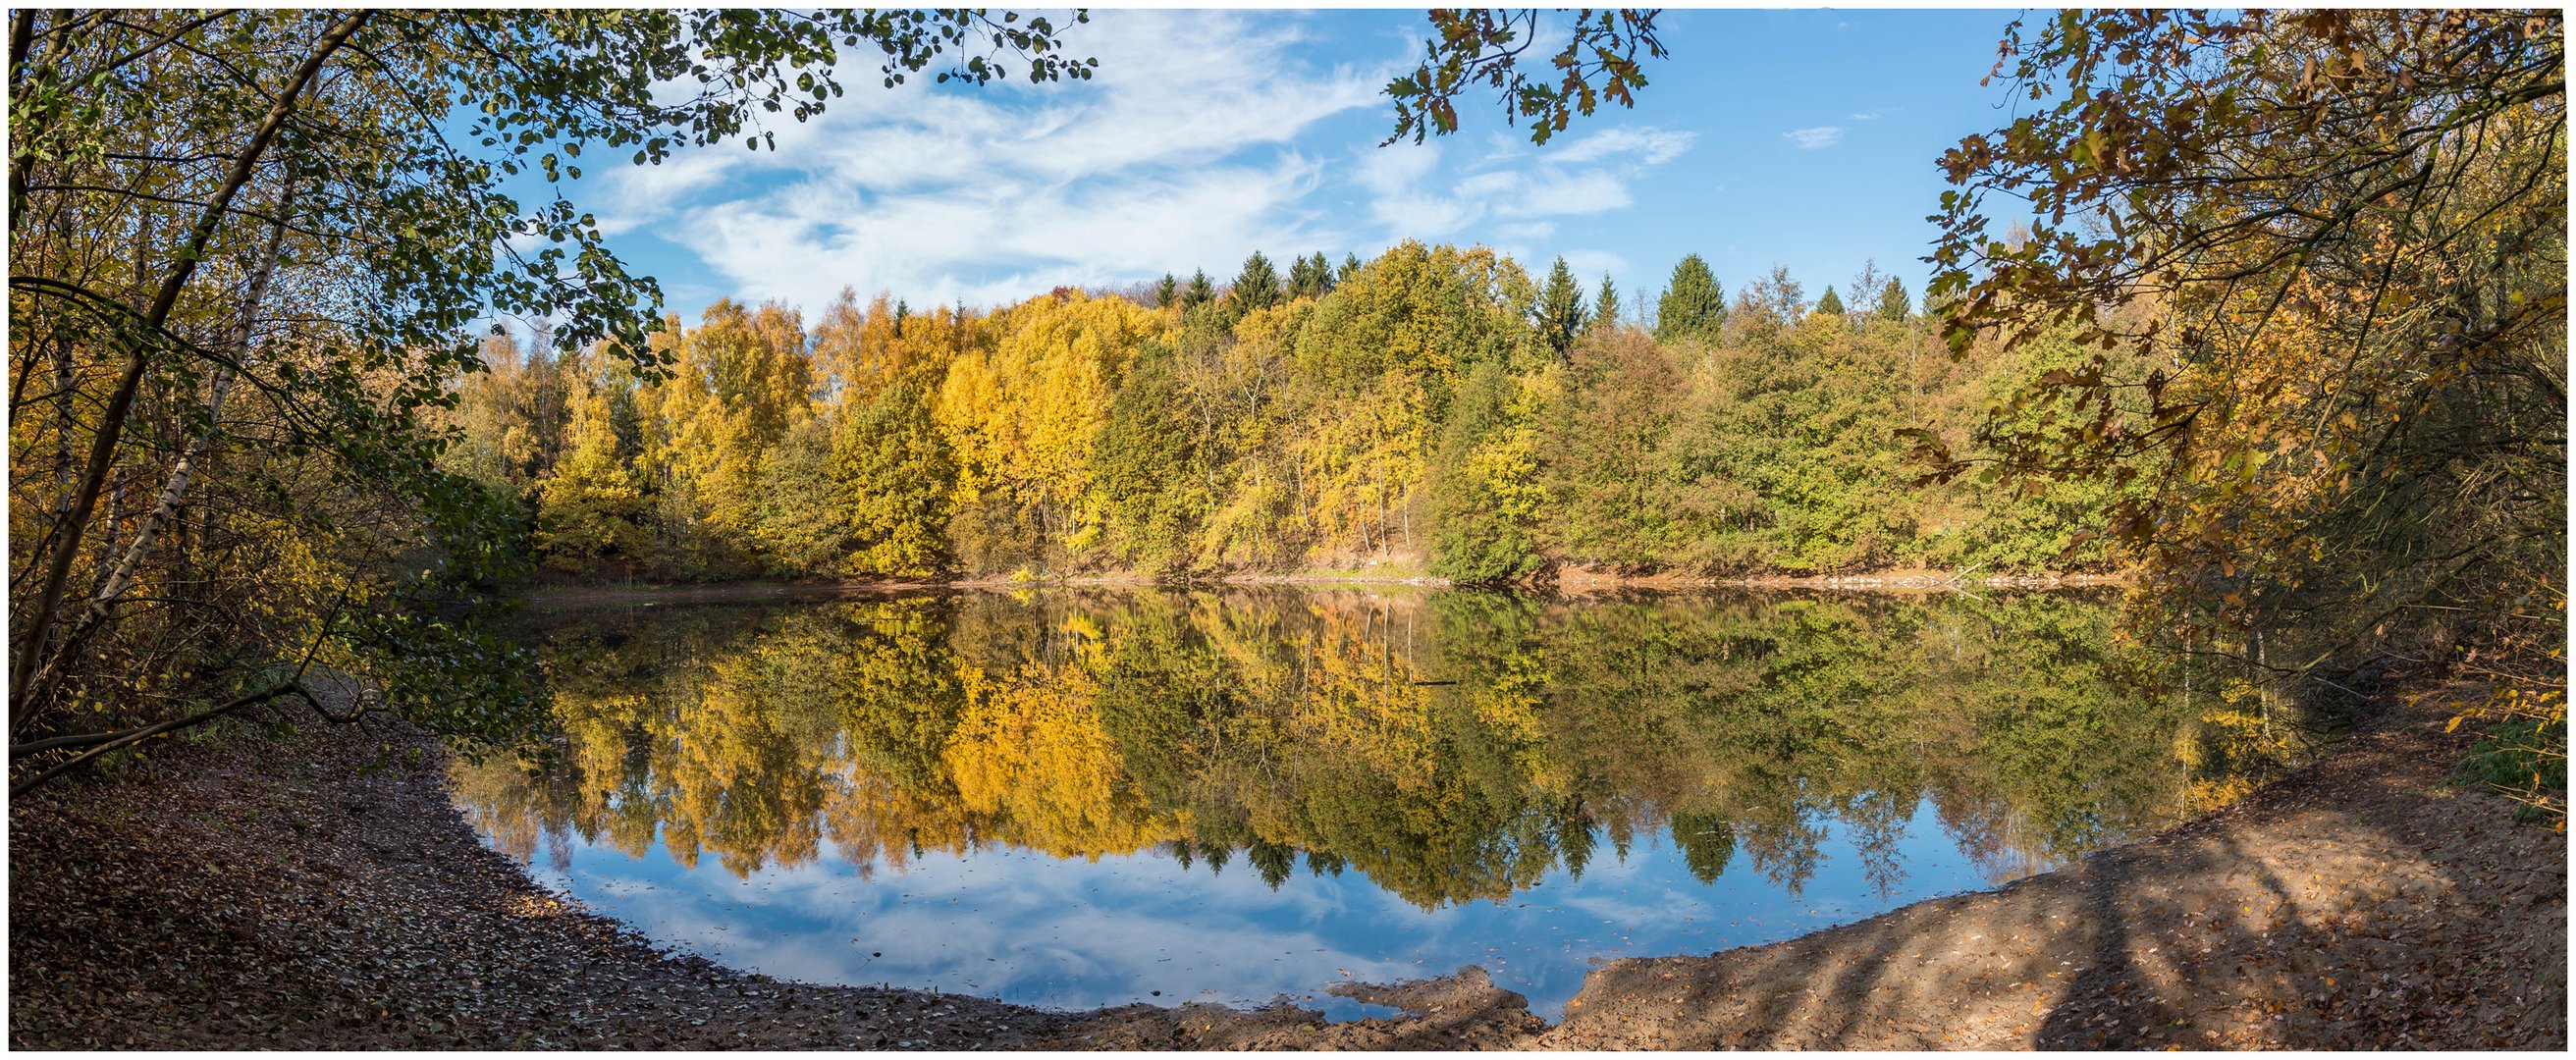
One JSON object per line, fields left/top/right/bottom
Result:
{"left": 8, "top": 689, "right": 2568, "bottom": 1050}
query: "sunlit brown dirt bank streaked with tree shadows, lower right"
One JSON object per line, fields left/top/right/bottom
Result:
{"left": 1540, "top": 694, "right": 2566, "bottom": 1050}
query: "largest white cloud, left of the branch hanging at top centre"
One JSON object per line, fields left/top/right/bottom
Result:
{"left": 623, "top": 10, "right": 1409, "bottom": 309}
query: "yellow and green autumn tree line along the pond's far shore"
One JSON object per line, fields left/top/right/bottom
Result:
{"left": 443, "top": 241, "right": 2118, "bottom": 584}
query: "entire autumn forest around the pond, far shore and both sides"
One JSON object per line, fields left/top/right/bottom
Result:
{"left": 8, "top": 10, "right": 2566, "bottom": 813}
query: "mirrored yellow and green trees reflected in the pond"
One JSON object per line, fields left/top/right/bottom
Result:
{"left": 454, "top": 589, "right": 2208, "bottom": 908}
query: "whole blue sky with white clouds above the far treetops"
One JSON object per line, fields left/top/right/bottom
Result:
{"left": 572, "top": 10, "right": 2014, "bottom": 319}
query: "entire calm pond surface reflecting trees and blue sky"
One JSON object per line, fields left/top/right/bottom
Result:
{"left": 456, "top": 589, "right": 2197, "bottom": 1019}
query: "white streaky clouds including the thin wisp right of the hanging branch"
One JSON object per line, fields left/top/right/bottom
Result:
{"left": 593, "top": 10, "right": 1695, "bottom": 314}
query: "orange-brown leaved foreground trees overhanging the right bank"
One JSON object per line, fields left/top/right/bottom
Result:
{"left": 1924, "top": 10, "right": 2568, "bottom": 805}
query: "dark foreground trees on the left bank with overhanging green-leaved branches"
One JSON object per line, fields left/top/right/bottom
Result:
{"left": 8, "top": 10, "right": 1090, "bottom": 787}
